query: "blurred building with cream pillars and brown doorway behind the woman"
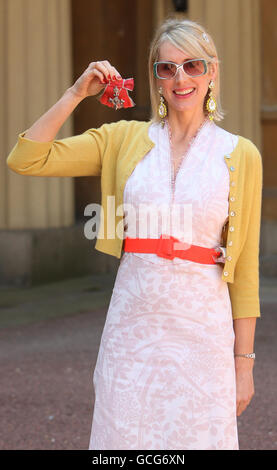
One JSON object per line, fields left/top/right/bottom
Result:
{"left": 0, "top": 0, "right": 277, "bottom": 285}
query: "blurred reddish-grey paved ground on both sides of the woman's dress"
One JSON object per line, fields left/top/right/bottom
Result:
{"left": 0, "top": 275, "right": 277, "bottom": 450}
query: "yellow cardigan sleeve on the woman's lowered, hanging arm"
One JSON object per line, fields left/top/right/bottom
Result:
{"left": 228, "top": 144, "right": 263, "bottom": 319}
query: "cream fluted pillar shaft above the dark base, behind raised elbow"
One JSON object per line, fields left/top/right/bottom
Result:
{"left": 0, "top": 0, "right": 74, "bottom": 230}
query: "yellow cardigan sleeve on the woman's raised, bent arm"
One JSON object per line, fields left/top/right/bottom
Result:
{"left": 7, "top": 123, "right": 116, "bottom": 176}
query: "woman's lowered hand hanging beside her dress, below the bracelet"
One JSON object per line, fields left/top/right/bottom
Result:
{"left": 235, "top": 357, "right": 254, "bottom": 416}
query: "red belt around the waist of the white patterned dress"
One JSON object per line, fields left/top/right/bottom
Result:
{"left": 123, "top": 235, "right": 222, "bottom": 264}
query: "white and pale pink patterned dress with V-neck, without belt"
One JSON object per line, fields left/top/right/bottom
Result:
{"left": 89, "top": 116, "right": 238, "bottom": 450}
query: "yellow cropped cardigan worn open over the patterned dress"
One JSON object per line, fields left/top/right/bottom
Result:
{"left": 7, "top": 120, "right": 263, "bottom": 319}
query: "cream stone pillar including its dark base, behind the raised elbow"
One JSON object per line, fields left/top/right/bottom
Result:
{"left": 0, "top": 0, "right": 100, "bottom": 285}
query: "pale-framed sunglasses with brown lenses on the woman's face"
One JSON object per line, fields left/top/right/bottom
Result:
{"left": 153, "top": 59, "right": 207, "bottom": 80}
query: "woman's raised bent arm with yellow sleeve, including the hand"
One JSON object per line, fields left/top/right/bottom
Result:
{"left": 7, "top": 61, "right": 119, "bottom": 176}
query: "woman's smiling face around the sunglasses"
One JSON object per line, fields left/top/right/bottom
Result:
{"left": 156, "top": 41, "right": 217, "bottom": 118}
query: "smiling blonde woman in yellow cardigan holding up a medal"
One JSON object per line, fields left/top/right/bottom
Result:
{"left": 7, "top": 19, "right": 262, "bottom": 450}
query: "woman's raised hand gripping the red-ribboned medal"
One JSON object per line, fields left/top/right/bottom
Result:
{"left": 70, "top": 60, "right": 121, "bottom": 99}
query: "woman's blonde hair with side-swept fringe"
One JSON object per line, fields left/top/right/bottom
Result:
{"left": 148, "top": 18, "right": 225, "bottom": 122}
